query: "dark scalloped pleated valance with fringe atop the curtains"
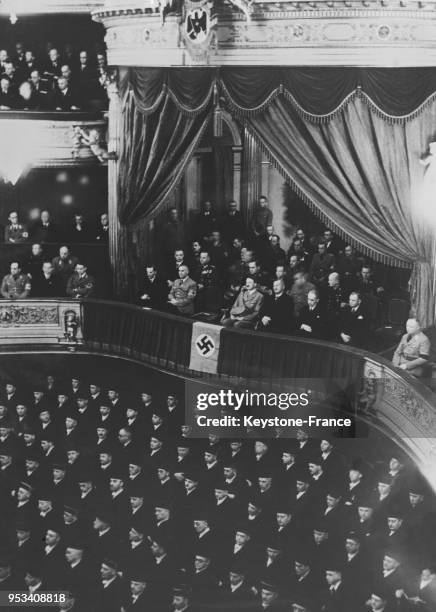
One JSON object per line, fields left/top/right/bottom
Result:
{"left": 120, "top": 67, "right": 436, "bottom": 122}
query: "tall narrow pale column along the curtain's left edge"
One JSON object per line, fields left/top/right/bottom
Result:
{"left": 107, "top": 83, "right": 125, "bottom": 295}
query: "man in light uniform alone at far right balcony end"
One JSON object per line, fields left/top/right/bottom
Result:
{"left": 392, "top": 317, "right": 431, "bottom": 377}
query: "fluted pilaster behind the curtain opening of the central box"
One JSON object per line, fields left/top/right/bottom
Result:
{"left": 241, "top": 130, "right": 262, "bottom": 224}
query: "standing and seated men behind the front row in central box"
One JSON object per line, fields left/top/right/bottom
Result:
{"left": 157, "top": 201, "right": 407, "bottom": 293}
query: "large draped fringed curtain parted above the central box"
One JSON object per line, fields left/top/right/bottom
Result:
{"left": 120, "top": 68, "right": 436, "bottom": 325}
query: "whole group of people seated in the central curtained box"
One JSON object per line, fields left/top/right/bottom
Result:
{"left": 137, "top": 197, "right": 408, "bottom": 346}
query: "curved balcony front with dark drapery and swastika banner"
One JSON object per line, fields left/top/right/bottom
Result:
{"left": 0, "top": 300, "right": 436, "bottom": 491}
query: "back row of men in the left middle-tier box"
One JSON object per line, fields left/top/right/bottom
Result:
{"left": 4, "top": 210, "right": 109, "bottom": 244}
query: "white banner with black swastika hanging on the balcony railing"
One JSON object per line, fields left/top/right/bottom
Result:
{"left": 189, "top": 321, "right": 221, "bottom": 374}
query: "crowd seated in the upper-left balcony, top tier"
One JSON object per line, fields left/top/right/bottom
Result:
{"left": 0, "top": 42, "right": 109, "bottom": 111}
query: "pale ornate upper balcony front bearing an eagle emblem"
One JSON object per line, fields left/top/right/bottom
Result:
{"left": 93, "top": 0, "right": 436, "bottom": 67}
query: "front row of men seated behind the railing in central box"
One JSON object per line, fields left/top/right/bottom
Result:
{"left": 137, "top": 249, "right": 386, "bottom": 346}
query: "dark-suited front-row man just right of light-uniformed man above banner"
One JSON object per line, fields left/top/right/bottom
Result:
{"left": 259, "top": 279, "right": 295, "bottom": 334}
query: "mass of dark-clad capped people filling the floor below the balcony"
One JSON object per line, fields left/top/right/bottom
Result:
{"left": 0, "top": 375, "right": 436, "bottom": 612}
